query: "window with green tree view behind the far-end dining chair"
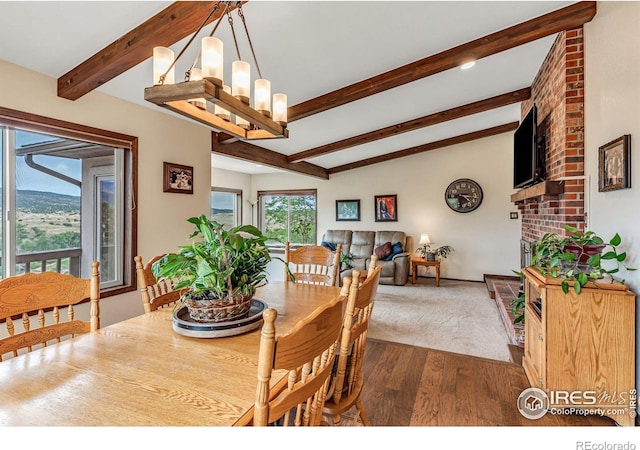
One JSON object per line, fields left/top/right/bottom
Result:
{"left": 258, "top": 189, "right": 317, "bottom": 246}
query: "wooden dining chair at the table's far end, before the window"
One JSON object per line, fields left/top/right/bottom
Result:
{"left": 284, "top": 242, "right": 342, "bottom": 286}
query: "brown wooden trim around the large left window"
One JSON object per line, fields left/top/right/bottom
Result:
{"left": 0, "top": 106, "right": 138, "bottom": 298}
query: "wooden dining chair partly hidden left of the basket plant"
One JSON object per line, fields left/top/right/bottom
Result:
{"left": 133, "top": 255, "right": 181, "bottom": 313}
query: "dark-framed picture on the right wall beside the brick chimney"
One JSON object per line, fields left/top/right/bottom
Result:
{"left": 598, "top": 134, "right": 631, "bottom": 192}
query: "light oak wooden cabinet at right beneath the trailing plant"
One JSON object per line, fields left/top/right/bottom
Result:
{"left": 522, "top": 267, "right": 637, "bottom": 425}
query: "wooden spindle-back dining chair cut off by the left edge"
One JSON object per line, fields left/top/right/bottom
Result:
{"left": 0, "top": 261, "right": 100, "bottom": 361}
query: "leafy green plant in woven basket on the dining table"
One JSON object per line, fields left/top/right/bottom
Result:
{"left": 152, "top": 215, "right": 279, "bottom": 322}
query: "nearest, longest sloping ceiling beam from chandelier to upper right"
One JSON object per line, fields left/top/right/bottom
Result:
{"left": 288, "top": 2, "right": 597, "bottom": 122}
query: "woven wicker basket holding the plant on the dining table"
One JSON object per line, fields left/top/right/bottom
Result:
{"left": 185, "top": 295, "right": 253, "bottom": 323}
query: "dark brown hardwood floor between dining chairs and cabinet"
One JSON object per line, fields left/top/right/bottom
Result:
{"left": 362, "top": 339, "right": 614, "bottom": 426}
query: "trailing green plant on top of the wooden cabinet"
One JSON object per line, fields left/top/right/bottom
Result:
{"left": 531, "top": 225, "right": 635, "bottom": 294}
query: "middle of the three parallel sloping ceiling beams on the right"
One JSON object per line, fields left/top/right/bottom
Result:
{"left": 287, "top": 88, "right": 531, "bottom": 162}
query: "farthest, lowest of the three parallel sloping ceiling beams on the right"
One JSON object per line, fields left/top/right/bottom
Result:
{"left": 327, "top": 122, "right": 519, "bottom": 175}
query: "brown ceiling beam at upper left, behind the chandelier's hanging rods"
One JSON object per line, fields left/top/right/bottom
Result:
{"left": 58, "top": 1, "right": 241, "bottom": 100}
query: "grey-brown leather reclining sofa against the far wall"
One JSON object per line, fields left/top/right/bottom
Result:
{"left": 322, "top": 230, "right": 413, "bottom": 286}
